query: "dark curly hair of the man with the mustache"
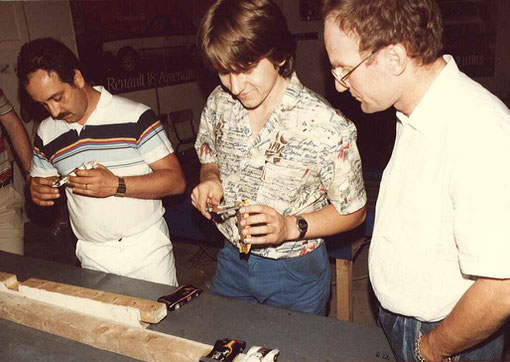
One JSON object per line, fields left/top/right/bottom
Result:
{"left": 16, "top": 38, "right": 85, "bottom": 86}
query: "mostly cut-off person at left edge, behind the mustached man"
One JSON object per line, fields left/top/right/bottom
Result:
{"left": 0, "top": 89, "right": 32, "bottom": 255}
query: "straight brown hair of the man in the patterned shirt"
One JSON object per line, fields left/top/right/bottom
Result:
{"left": 197, "top": 0, "right": 296, "bottom": 78}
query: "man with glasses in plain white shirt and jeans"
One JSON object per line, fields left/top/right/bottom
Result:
{"left": 324, "top": 0, "right": 510, "bottom": 361}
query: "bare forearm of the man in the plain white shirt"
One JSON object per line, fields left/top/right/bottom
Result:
{"left": 421, "top": 278, "right": 510, "bottom": 360}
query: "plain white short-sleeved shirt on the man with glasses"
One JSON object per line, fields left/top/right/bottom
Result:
{"left": 369, "top": 56, "right": 510, "bottom": 322}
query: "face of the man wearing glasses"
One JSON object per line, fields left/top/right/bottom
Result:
{"left": 324, "top": 19, "right": 394, "bottom": 113}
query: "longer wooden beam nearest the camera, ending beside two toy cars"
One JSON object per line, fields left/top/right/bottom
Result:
{"left": 0, "top": 292, "right": 212, "bottom": 362}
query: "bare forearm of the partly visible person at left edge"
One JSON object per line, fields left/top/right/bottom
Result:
{"left": 0, "top": 111, "right": 32, "bottom": 171}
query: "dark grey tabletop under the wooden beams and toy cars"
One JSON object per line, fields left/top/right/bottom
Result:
{"left": 0, "top": 252, "right": 393, "bottom": 362}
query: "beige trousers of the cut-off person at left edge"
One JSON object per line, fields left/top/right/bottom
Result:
{"left": 0, "top": 183, "right": 24, "bottom": 255}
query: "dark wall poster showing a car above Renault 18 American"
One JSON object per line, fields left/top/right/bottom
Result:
{"left": 70, "top": 0, "right": 212, "bottom": 94}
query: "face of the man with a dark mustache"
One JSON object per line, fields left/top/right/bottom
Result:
{"left": 26, "top": 69, "right": 88, "bottom": 124}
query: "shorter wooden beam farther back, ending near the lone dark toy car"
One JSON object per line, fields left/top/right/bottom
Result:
{"left": 19, "top": 278, "right": 167, "bottom": 327}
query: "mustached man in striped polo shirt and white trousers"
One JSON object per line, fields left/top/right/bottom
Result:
{"left": 17, "top": 38, "right": 185, "bottom": 285}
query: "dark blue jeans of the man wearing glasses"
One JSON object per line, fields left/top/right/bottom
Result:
{"left": 379, "top": 308, "right": 505, "bottom": 361}
